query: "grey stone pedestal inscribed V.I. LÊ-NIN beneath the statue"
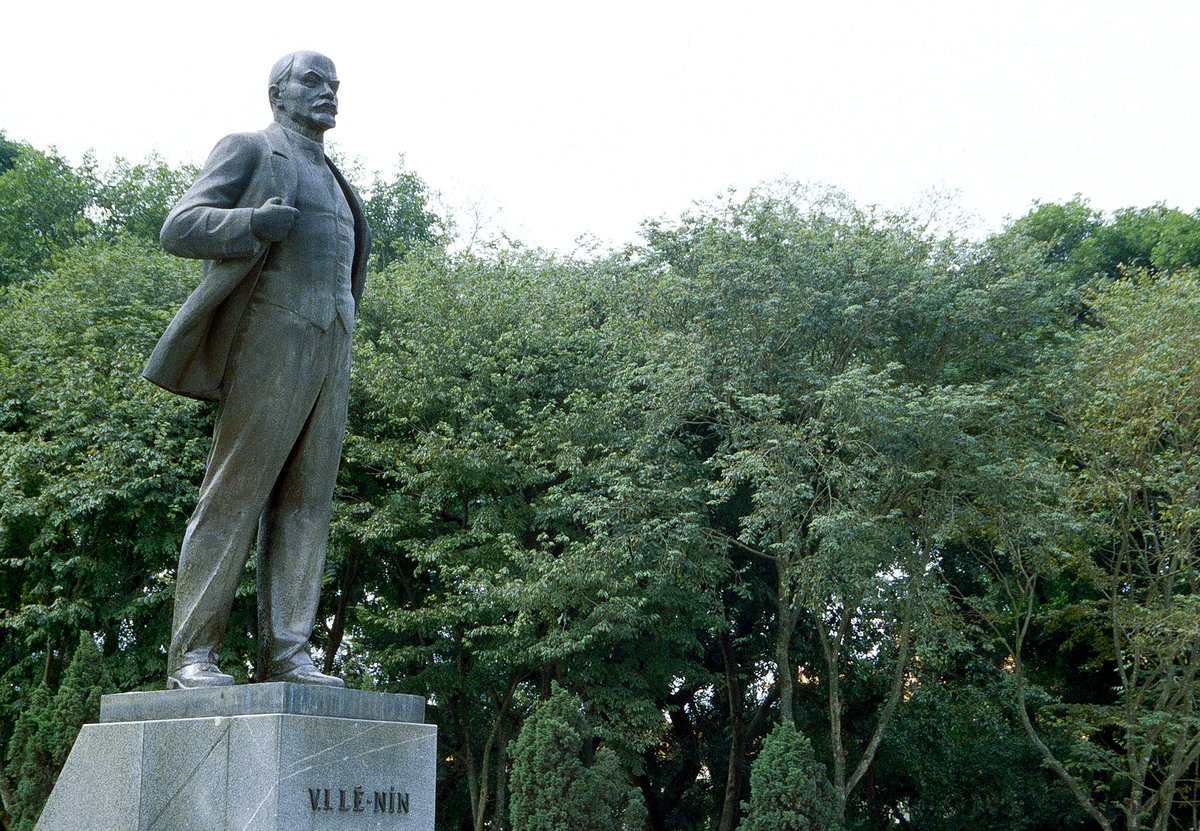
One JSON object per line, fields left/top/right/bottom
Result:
{"left": 35, "top": 683, "right": 437, "bottom": 831}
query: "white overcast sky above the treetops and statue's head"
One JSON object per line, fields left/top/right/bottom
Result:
{"left": 0, "top": 0, "right": 1200, "bottom": 251}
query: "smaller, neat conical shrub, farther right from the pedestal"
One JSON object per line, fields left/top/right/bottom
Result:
{"left": 738, "top": 722, "right": 842, "bottom": 831}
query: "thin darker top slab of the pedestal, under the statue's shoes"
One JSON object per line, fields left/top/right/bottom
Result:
{"left": 100, "top": 681, "right": 425, "bottom": 724}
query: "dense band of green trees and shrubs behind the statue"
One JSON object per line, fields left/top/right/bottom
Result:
{"left": 0, "top": 134, "right": 1200, "bottom": 831}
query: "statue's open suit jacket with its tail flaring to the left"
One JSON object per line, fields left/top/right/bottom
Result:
{"left": 142, "top": 124, "right": 371, "bottom": 401}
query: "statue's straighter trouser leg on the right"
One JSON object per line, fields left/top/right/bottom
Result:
{"left": 257, "top": 321, "right": 350, "bottom": 680}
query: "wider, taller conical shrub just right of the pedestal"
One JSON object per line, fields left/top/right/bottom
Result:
{"left": 511, "top": 684, "right": 646, "bottom": 831}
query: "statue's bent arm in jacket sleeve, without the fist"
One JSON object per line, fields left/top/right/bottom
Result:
{"left": 158, "top": 133, "right": 264, "bottom": 259}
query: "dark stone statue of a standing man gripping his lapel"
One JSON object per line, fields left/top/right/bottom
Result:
{"left": 143, "top": 52, "right": 370, "bottom": 688}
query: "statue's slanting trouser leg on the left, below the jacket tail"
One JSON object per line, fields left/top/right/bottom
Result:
{"left": 167, "top": 303, "right": 322, "bottom": 672}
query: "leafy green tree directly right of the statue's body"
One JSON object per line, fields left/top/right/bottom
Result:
{"left": 331, "top": 251, "right": 704, "bottom": 827}
